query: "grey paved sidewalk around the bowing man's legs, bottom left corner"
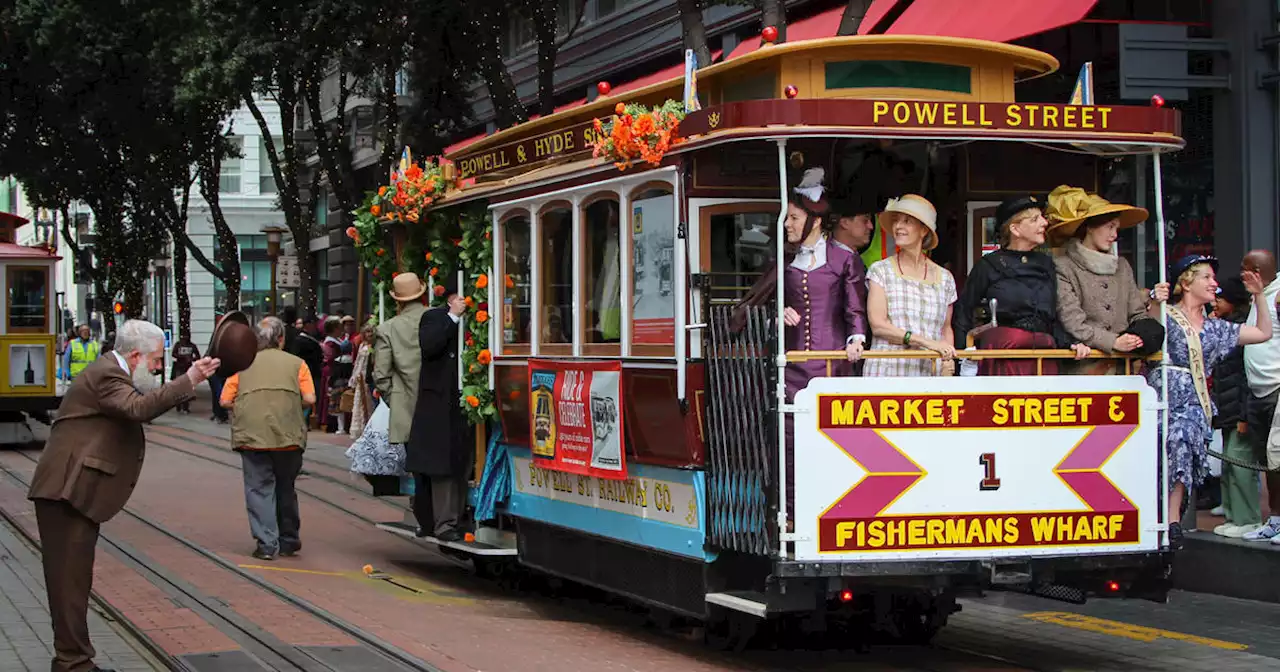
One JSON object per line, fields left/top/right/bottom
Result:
{"left": 0, "top": 521, "right": 163, "bottom": 672}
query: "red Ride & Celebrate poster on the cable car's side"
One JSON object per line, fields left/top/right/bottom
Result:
{"left": 529, "top": 360, "right": 627, "bottom": 479}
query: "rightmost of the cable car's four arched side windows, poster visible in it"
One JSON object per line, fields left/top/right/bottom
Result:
{"left": 630, "top": 187, "right": 676, "bottom": 353}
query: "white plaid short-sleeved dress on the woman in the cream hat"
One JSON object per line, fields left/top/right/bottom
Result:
{"left": 863, "top": 257, "right": 956, "bottom": 376}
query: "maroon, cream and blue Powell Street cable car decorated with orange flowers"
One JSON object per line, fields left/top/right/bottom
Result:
{"left": 373, "top": 36, "right": 1183, "bottom": 639}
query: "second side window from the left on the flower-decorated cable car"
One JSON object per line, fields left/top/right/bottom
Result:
{"left": 539, "top": 206, "right": 576, "bottom": 349}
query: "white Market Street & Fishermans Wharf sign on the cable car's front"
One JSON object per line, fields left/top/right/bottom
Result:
{"left": 794, "top": 376, "right": 1160, "bottom": 562}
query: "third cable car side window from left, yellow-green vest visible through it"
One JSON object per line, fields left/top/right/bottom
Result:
{"left": 582, "top": 196, "right": 622, "bottom": 353}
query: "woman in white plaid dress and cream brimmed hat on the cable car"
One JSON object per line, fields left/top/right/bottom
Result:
{"left": 863, "top": 193, "right": 956, "bottom": 376}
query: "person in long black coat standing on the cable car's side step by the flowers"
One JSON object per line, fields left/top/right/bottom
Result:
{"left": 404, "top": 291, "right": 475, "bottom": 541}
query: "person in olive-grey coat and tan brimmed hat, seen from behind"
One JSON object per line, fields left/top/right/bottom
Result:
{"left": 366, "top": 273, "right": 431, "bottom": 519}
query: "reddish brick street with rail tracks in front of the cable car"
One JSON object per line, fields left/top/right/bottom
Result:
{"left": 0, "top": 386, "right": 1280, "bottom": 672}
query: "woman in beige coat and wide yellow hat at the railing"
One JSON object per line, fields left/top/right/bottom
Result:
{"left": 1048, "top": 186, "right": 1169, "bottom": 372}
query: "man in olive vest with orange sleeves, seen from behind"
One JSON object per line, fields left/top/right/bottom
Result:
{"left": 219, "top": 317, "right": 316, "bottom": 561}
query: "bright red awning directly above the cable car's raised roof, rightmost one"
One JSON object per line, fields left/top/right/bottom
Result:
{"left": 858, "top": 0, "right": 1098, "bottom": 42}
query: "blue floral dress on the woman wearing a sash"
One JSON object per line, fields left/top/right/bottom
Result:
{"left": 1147, "top": 308, "right": 1240, "bottom": 490}
